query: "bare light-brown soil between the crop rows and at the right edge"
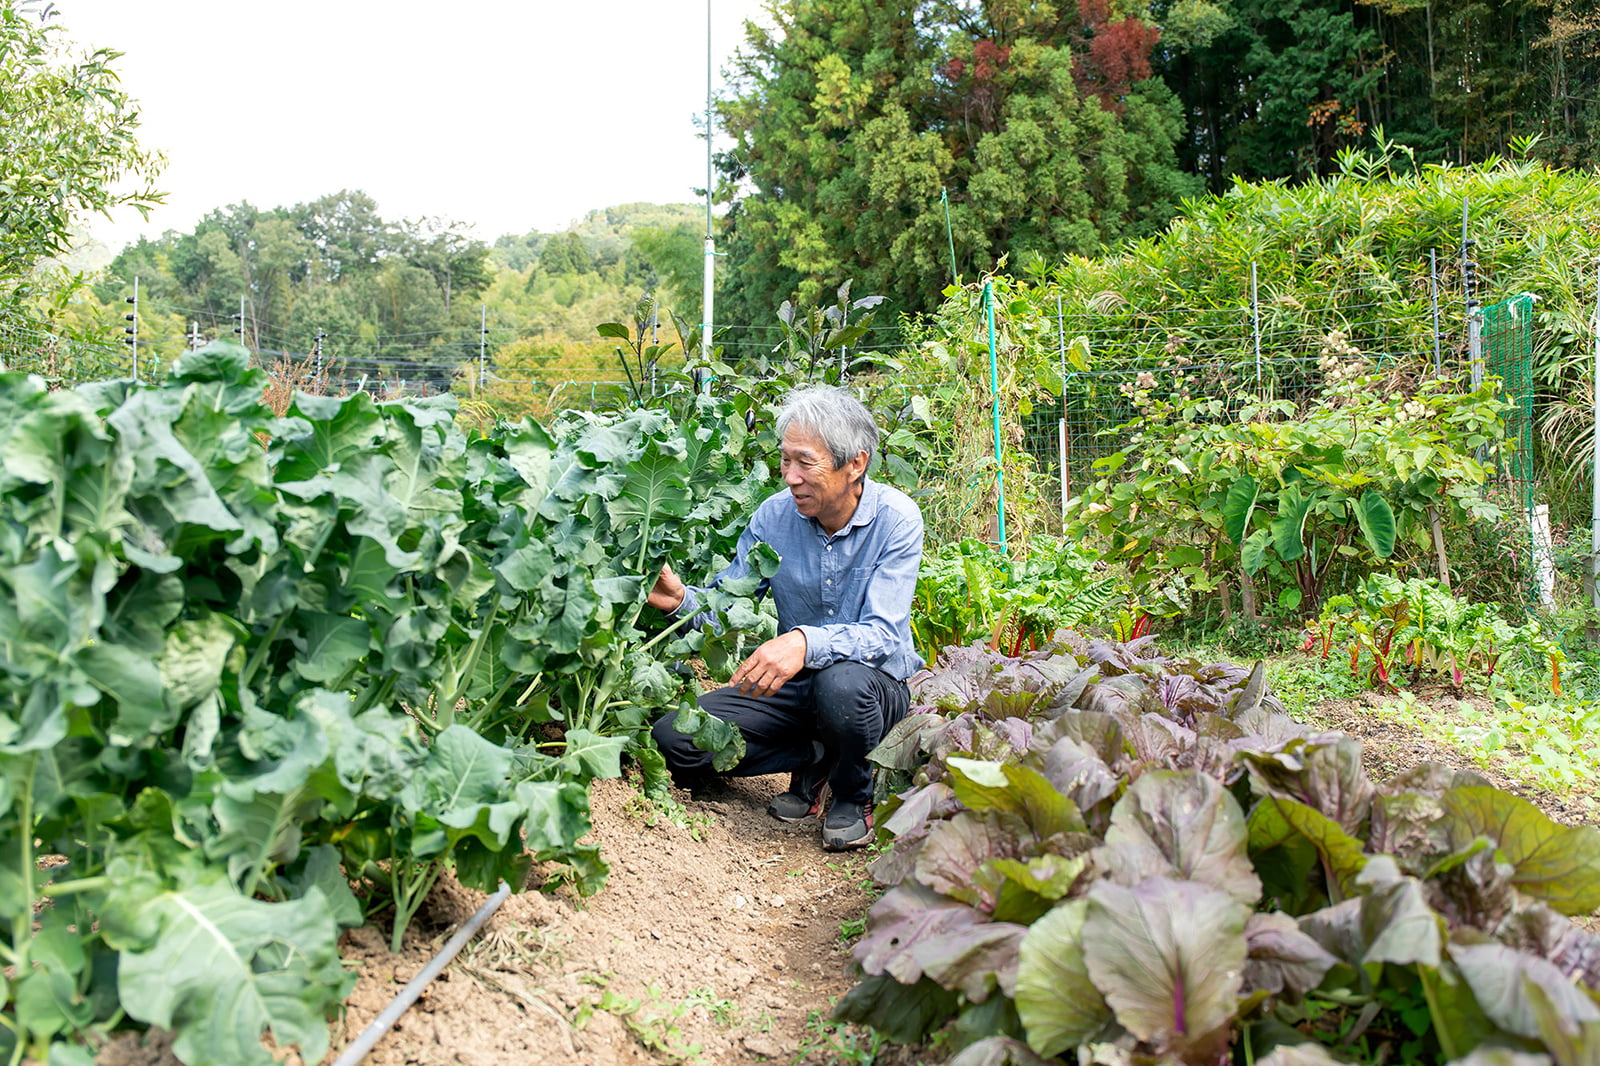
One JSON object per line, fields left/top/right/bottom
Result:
{"left": 99, "top": 695, "right": 1600, "bottom": 1066}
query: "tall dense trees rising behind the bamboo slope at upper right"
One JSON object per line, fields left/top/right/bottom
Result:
{"left": 718, "top": 0, "right": 1600, "bottom": 319}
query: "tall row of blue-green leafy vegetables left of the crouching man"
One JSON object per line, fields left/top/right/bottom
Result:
{"left": 0, "top": 344, "right": 763, "bottom": 1066}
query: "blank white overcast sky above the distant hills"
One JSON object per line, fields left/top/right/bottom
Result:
{"left": 54, "top": 0, "right": 762, "bottom": 248}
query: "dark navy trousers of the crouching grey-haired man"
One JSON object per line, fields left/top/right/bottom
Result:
{"left": 651, "top": 663, "right": 910, "bottom": 810}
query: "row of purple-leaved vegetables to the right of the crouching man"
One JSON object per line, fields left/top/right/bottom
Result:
{"left": 835, "top": 640, "right": 1600, "bottom": 1066}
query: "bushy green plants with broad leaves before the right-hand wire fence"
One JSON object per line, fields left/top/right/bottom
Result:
{"left": 1069, "top": 360, "right": 1504, "bottom": 618}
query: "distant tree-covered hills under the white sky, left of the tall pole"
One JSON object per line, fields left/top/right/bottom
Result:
{"left": 53, "top": 190, "right": 704, "bottom": 389}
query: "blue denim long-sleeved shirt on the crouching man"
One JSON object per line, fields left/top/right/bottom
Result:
{"left": 674, "top": 479, "right": 922, "bottom": 680}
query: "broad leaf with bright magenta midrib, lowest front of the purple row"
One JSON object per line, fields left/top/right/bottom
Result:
{"left": 1083, "top": 877, "right": 1250, "bottom": 1058}
